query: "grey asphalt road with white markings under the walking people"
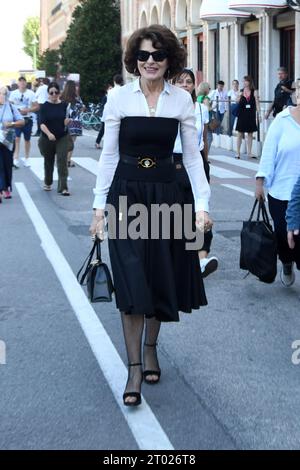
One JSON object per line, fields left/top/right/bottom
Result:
{"left": 0, "top": 135, "right": 300, "bottom": 450}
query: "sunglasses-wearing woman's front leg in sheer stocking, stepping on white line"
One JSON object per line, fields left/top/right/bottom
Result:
{"left": 121, "top": 313, "right": 144, "bottom": 403}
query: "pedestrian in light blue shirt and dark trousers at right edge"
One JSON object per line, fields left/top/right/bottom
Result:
{"left": 256, "top": 80, "right": 300, "bottom": 287}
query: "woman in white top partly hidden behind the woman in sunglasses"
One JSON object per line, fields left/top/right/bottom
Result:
{"left": 173, "top": 69, "right": 218, "bottom": 278}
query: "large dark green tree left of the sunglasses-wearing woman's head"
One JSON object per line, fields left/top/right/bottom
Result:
{"left": 60, "top": 0, "right": 122, "bottom": 102}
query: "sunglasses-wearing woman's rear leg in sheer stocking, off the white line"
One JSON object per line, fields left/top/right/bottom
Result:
{"left": 144, "top": 318, "right": 161, "bottom": 383}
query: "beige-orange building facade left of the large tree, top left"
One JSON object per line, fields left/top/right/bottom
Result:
{"left": 40, "top": 0, "right": 80, "bottom": 52}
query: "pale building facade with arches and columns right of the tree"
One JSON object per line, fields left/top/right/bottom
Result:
{"left": 121, "top": 0, "right": 300, "bottom": 101}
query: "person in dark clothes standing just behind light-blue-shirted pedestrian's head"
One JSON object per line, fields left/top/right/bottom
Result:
{"left": 265, "top": 67, "right": 293, "bottom": 119}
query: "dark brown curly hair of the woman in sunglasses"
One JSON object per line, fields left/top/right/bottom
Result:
{"left": 124, "top": 24, "right": 186, "bottom": 79}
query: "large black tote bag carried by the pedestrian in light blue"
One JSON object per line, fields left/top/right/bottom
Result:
{"left": 240, "top": 200, "right": 277, "bottom": 284}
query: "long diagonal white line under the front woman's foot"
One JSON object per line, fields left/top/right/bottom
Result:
{"left": 15, "top": 183, "right": 174, "bottom": 450}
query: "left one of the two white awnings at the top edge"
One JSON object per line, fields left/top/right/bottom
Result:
{"left": 200, "top": 0, "right": 249, "bottom": 22}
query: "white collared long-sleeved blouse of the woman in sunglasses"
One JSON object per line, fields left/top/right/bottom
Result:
{"left": 93, "top": 79, "right": 210, "bottom": 212}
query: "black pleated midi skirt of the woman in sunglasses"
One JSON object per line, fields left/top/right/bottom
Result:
{"left": 107, "top": 163, "right": 207, "bottom": 322}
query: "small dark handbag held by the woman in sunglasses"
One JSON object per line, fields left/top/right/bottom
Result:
{"left": 77, "top": 238, "right": 114, "bottom": 303}
